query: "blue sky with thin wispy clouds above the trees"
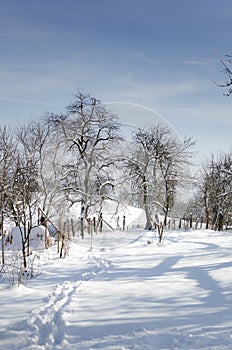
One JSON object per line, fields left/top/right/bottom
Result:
{"left": 0, "top": 0, "right": 232, "bottom": 161}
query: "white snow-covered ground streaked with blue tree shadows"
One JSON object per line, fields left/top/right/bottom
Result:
{"left": 0, "top": 228, "right": 232, "bottom": 350}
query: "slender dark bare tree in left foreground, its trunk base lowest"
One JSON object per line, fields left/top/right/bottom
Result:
{"left": 3, "top": 122, "right": 55, "bottom": 267}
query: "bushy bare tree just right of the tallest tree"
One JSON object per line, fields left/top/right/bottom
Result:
{"left": 126, "top": 124, "right": 194, "bottom": 234}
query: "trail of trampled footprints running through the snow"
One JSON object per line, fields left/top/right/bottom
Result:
{"left": 20, "top": 256, "right": 112, "bottom": 349}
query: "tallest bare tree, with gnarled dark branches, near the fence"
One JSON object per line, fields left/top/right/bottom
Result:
{"left": 47, "top": 92, "right": 120, "bottom": 237}
